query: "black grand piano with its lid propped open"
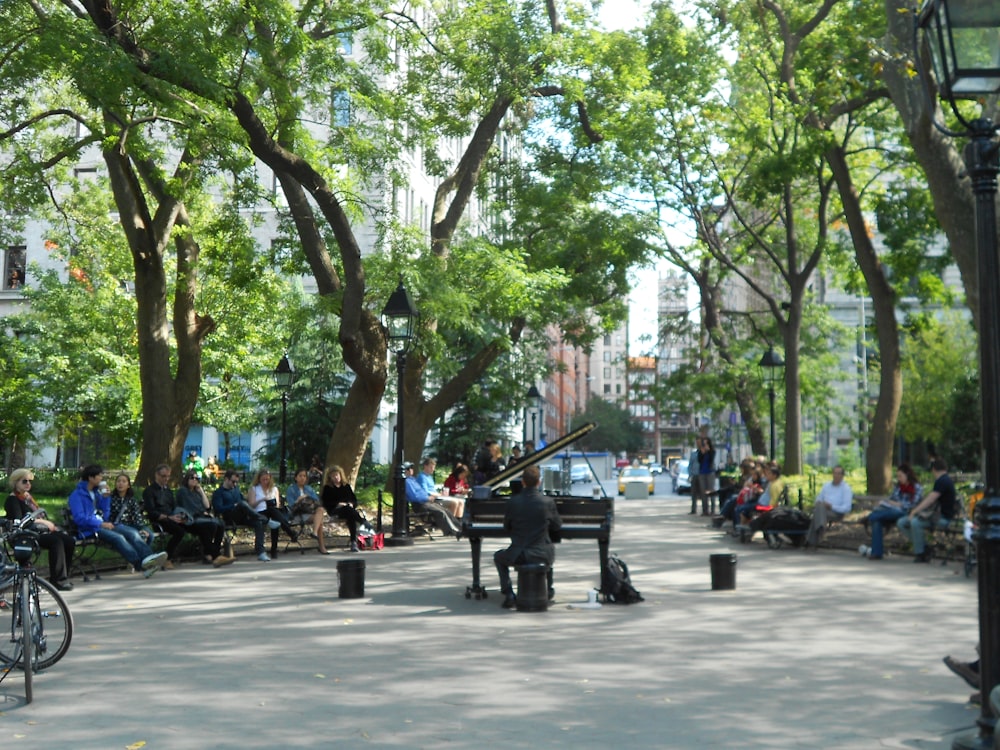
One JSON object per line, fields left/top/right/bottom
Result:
{"left": 462, "top": 422, "right": 615, "bottom": 599}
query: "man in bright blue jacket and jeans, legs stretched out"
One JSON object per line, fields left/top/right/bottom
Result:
{"left": 69, "top": 464, "right": 167, "bottom": 578}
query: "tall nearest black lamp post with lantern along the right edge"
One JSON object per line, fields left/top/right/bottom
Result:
{"left": 914, "top": 0, "right": 1000, "bottom": 750}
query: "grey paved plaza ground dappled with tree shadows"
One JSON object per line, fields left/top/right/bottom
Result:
{"left": 0, "top": 496, "right": 978, "bottom": 750}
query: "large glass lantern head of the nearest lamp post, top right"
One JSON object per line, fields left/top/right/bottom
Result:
{"left": 917, "top": 0, "right": 1000, "bottom": 99}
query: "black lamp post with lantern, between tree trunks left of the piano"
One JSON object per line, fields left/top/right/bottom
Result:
{"left": 382, "top": 279, "right": 419, "bottom": 546}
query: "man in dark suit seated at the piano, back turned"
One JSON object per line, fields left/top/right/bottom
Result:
{"left": 493, "top": 466, "right": 562, "bottom": 609}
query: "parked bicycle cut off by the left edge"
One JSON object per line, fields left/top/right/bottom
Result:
{"left": 0, "top": 512, "right": 73, "bottom": 703}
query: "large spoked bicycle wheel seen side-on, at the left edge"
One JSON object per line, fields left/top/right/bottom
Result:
{"left": 0, "top": 576, "right": 73, "bottom": 672}
